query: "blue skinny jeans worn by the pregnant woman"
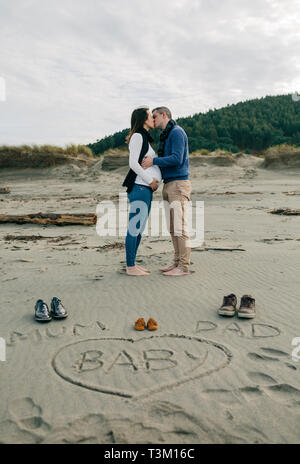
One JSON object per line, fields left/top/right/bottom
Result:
{"left": 125, "top": 184, "right": 153, "bottom": 266}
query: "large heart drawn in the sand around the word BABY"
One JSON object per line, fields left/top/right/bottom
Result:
{"left": 52, "top": 334, "right": 232, "bottom": 399}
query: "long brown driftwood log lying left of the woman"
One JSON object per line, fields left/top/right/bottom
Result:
{"left": 0, "top": 213, "right": 97, "bottom": 226}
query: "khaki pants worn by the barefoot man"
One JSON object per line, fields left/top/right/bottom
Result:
{"left": 162, "top": 180, "right": 192, "bottom": 272}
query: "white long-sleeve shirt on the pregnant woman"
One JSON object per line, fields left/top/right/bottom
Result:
{"left": 128, "top": 132, "right": 161, "bottom": 186}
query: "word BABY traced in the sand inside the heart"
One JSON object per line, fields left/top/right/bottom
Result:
{"left": 73, "top": 349, "right": 199, "bottom": 374}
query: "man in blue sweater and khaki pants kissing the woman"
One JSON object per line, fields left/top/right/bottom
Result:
{"left": 142, "top": 106, "right": 192, "bottom": 276}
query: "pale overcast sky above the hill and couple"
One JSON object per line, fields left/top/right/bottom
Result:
{"left": 0, "top": 0, "right": 300, "bottom": 146}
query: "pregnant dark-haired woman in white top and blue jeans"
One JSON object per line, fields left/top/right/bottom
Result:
{"left": 123, "top": 107, "right": 161, "bottom": 276}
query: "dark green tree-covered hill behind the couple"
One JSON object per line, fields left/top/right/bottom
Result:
{"left": 87, "top": 94, "right": 300, "bottom": 155}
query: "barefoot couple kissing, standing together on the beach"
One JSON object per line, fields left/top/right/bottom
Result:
{"left": 122, "top": 106, "right": 192, "bottom": 277}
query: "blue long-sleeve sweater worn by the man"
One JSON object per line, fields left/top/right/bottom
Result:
{"left": 153, "top": 125, "right": 190, "bottom": 184}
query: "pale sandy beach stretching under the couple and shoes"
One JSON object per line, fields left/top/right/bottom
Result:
{"left": 0, "top": 157, "right": 300, "bottom": 444}
